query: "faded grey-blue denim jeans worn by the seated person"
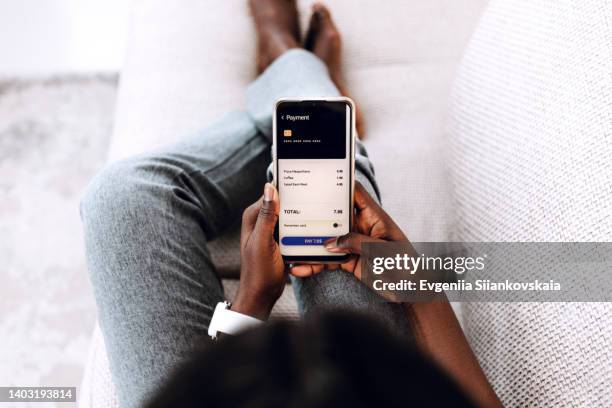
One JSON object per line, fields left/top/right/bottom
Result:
{"left": 81, "top": 50, "right": 408, "bottom": 407}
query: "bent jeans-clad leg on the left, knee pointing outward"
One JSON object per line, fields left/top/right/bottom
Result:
{"left": 81, "top": 113, "right": 269, "bottom": 407}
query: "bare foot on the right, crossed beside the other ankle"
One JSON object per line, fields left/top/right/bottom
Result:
{"left": 304, "top": 3, "right": 363, "bottom": 138}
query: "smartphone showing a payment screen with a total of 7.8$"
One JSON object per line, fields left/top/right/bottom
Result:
{"left": 272, "top": 97, "right": 355, "bottom": 263}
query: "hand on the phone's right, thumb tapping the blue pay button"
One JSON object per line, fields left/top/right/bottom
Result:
{"left": 290, "top": 182, "right": 408, "bottom": 279}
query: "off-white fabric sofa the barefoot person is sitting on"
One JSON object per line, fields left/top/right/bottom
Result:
{"left": 80, "top": 0, "right": 612, "bottom": 407}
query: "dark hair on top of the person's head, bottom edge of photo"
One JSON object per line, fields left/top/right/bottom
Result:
{"left": 148, "top": 312, "right": 474, "bottom": 408}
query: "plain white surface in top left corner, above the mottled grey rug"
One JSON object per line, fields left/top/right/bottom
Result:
{"left": 0, "top": 0, "right": 130, "bottom": 76}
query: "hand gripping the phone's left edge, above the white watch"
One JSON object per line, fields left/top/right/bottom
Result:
{"left": 232, "top": 183, "right": 287, "bottom": 320}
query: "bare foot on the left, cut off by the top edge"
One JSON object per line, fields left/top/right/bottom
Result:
{"left": 249, "top": 0, "right": 300, "bottom": 73}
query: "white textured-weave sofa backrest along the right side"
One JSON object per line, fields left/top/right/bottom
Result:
{"left": 450, "top": 0, "right": 612, "bottom": 407}
